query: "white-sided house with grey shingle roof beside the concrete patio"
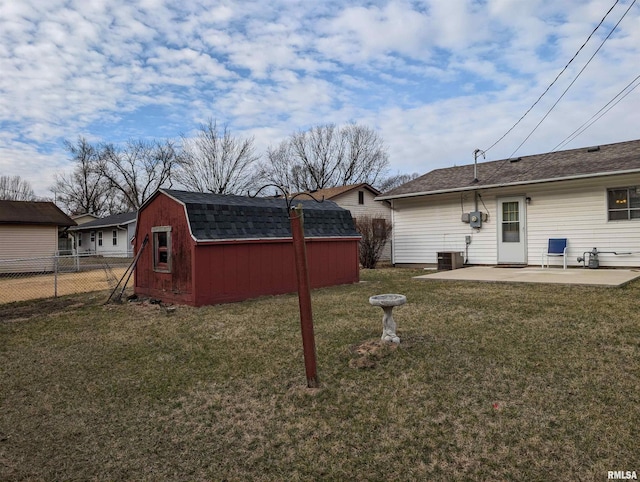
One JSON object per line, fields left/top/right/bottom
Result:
{"left": 377, "top": 140, "right": 640, "bottom": 267}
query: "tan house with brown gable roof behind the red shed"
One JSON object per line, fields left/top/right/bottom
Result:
{"left": 294, "top": 183, "right": 391, "bottom": 260}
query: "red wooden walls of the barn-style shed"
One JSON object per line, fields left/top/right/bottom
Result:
{"left": 135, "top": 193, "right": 359, "bottom": 306}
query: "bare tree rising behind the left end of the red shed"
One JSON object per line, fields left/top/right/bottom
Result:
{"left": 97, "top": 140, "right": 179, "bottom": 209}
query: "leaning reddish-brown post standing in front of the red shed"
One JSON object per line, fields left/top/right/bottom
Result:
{"left": 289, "top": 204, "right": 320, "bottom": 388}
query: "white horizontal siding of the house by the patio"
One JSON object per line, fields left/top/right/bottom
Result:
{"left": 393, "top": 174, "right": 640, "bottom": 267}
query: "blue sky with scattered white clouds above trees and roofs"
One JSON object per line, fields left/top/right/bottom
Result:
{"left": 0, "top": 0, "right": 640, "bottom": 196}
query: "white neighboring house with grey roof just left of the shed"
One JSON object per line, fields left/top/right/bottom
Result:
{"left": 69, "top": 211, "right": 137, "bottom": 257}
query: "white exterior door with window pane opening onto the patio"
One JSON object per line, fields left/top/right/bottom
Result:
{"left": 498, "top": 197, "right": 527, "bottom": 264}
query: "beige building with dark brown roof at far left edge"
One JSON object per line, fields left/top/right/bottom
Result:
{"left": 0, "top": 201, "right": 76, "bottom": 272}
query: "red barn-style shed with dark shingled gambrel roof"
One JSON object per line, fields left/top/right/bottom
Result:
{"left": 135, "top": 189, "right": 360, "bottom": 306}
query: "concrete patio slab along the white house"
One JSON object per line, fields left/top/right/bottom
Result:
{"left": 415, "top": 266, "right": 640, "bottom": 287}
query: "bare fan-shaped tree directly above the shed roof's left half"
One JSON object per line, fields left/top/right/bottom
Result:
{"left": 175, "top": 120, "right": 258, "bottom": 194}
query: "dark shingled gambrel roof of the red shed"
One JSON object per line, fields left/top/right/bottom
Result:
{"left": 156, "top": 189, "right": 360, "bottom": 241}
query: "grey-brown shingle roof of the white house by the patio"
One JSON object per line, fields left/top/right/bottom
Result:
{"left": 377, "top": 140, "right": 640, "bottom": 200}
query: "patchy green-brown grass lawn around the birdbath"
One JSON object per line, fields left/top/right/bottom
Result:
{"left": 0, "top": 269, "right": 640, "bottom": 481}
